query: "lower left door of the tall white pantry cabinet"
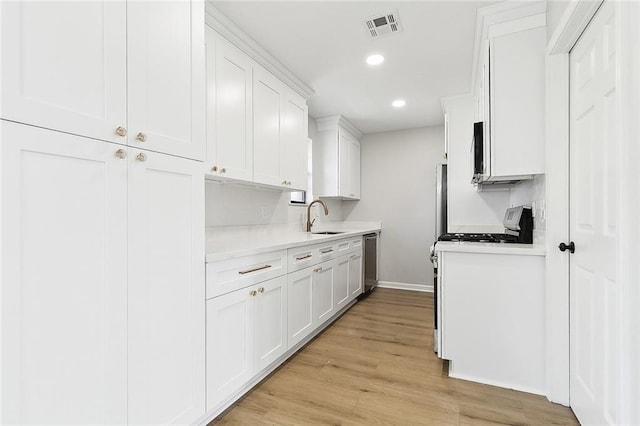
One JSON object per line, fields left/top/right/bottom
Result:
{"left": 0, "top": 121, "right": 127, "bottom": 424}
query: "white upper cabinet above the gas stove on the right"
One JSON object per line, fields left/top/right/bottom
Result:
{"left": 469, "top": 5, "right": 546, "bottom": 183}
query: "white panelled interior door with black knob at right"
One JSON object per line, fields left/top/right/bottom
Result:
{"left": 569, "top": 1, "right": 619, "bottom": 425}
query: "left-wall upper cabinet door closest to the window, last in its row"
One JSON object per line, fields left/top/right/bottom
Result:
{"left": 281, "top": 90, "right": 309, "bottom": 191}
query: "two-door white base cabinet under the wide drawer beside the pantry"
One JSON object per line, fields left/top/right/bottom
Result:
{"left": 207, "top": 275, "right": 287, "bottom": 410}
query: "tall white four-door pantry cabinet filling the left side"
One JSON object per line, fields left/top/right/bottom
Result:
{"left": 0, "top": 1, "right": 205, "bottom": 424}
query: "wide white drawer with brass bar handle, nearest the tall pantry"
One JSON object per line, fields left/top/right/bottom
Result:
{"left": 206, "top": 250, "right": 287, "bottom": 299}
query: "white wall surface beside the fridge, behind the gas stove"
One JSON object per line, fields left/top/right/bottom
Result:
{"left": 446, "top": 96, "right": 510, "bottom": 232}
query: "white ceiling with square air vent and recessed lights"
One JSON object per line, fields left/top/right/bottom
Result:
{"left": 213, "top": 0, "right": 495, "bottom": 133}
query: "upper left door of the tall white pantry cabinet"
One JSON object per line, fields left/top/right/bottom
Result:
{"left": 0, "top": 0, "right": 127, "bottom": 143}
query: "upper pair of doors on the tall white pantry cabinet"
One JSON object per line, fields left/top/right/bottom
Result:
{"left": 0, "top": 1, "right": 205, "bottom": 160}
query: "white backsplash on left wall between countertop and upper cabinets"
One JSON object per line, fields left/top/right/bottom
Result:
{"left": 205, "top": 181, "right": 343, "bottom": 231}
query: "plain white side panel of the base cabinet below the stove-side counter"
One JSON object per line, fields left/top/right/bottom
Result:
{"left": 441, "top": 252, "right": 545, "bottom": 394}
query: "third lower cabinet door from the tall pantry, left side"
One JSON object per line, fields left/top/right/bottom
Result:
{"left": 287, "top": 267, "right": 314, "bottom": 348}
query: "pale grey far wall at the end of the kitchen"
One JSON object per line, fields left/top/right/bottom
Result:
{"left": 343, "top": 127, "right": 444, "bottom": 288}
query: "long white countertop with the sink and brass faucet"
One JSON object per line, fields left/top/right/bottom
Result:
{"left": 205, "top": 222, "right": 381, "bottom": 263}
